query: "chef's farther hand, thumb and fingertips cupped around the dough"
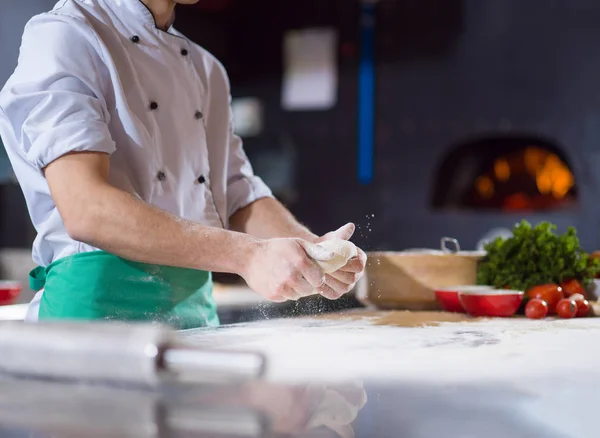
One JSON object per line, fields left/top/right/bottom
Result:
{"left": 317, "top": 224, "right": 367, "bottom": 300}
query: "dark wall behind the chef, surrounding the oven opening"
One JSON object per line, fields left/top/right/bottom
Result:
{"left": 0, "top": 0, "right": 600, "bottom": 249}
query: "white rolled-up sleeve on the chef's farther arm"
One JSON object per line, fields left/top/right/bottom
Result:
{"left": 227, "top": 130, "right": 273, "bottom": 217}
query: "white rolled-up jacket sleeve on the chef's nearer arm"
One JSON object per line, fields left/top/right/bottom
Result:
{"left": 0, "top": 13, "right": 115, "bottom": 170}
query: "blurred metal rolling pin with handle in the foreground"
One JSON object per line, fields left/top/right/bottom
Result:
{"left": 0, "top": 322, "right": 265, "bottom": 385}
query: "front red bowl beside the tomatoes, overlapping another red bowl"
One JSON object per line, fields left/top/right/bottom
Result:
{"left": 459, "top": 289, "right": 525, "bottom": 317}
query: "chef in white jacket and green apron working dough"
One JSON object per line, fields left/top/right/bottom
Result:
{"left": 0, "top": 0, "right": 366, "bottom": 328}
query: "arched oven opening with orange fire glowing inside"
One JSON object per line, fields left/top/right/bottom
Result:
{"left": 432, "top": 136, "right": 578, "bottom": 212}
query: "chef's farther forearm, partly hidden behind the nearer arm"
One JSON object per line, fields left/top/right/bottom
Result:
{"left": 230, "top": 198, "right": 317, "bottom": 242}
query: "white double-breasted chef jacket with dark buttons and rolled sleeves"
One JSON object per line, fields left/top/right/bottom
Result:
{"left": 0, "top": 0, "right": 271, "bottom": 266}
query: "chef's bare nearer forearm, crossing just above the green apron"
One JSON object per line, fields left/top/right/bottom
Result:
{"left": 65, "top": 185, "right": 256, "bottom": 274}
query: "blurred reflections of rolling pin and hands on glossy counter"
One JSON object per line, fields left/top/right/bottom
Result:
{"left": 0, "top": 380, "right": 367, "bottom": 438}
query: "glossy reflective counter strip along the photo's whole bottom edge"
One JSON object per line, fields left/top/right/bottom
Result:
{"left": 0, "top": 376, "right": 598, "bottom": 438}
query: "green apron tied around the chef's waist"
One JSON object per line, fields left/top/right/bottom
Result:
{"left": 29, "top": 251, "right": 219, "bottom": 329}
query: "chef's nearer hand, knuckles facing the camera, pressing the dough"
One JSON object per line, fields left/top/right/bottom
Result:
{"left": 241, "top": 238, "right": 325, "bottom": 302}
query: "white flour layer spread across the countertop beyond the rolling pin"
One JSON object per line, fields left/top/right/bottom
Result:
{"left": 182, "top": 316, "right": 600, "bottom": 383}
